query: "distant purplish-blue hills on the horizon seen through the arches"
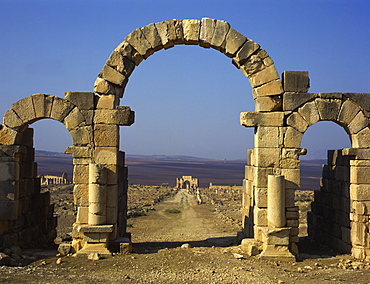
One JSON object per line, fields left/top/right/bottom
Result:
{"left": 35, "top": 150, "right": 325, "bottom": 189}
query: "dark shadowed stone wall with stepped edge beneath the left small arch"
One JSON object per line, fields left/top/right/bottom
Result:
{"left": 0, "top": 129, "right": 57, "bottom": 249}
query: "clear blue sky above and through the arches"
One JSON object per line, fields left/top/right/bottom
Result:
{"left": 0, "top": 0, "right": 370, "bottom": 159}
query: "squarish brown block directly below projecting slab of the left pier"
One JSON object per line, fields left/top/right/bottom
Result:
{"left": 94, "top": 124, "right": 119, "bottom": 147}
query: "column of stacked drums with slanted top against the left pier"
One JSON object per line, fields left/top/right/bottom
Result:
{"left": 88, "top": 163, "right": 107, "bottom": 225}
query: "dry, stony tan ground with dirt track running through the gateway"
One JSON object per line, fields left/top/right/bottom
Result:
{"left": 0, "top": 186, "right": 370, "bottom": 283}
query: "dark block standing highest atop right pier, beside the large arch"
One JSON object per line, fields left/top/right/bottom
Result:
{"left": 282, "top": 71, "right": 310, "bottom": 93}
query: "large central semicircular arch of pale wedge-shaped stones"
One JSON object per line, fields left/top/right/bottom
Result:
{"left": 94, "top": 18, "right": 283, "bottom": 111}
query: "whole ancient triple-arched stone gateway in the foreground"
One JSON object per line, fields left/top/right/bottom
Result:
{"left": 0, "top": 18, "right": 370, "bottom": 260}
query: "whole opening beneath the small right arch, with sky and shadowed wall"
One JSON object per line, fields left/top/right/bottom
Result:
{"left": 295, "top": 121, "right": 351, "bottom": 254}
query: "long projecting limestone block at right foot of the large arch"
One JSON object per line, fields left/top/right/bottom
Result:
{"left": 240, "top": 111, "right": 284, "bottom": 127}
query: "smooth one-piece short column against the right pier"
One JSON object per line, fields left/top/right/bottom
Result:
{"left": 267, "top": 175, "right": 286, "bottom": 228}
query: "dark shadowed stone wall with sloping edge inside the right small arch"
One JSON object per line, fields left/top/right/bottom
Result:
{"left": 308, "top": 150, "right": 351, "bottom": 253}
